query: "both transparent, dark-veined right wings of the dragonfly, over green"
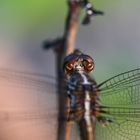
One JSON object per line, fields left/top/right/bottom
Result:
{"left": 96, "top": 68, "right": 140, "bottom": 140}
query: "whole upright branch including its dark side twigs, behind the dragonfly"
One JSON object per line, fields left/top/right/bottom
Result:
{"left": 43, "top": 0, "right": 102, "bottom": 140}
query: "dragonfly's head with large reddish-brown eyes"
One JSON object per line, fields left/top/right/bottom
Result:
{"left": 63, "top": 50, "right": 94, "bottom": 75}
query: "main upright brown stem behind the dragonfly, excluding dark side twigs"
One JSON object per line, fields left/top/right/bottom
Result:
{"left": 56, "top": 0, "right": 81, "bottom": 140}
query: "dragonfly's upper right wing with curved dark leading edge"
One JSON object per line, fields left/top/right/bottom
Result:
{"left": 98, "top": 68, "right": 140, "bottom": 105}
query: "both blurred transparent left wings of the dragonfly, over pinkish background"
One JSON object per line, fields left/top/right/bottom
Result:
{"left": 0, "top": 69, "right": 58, "bottom": 140}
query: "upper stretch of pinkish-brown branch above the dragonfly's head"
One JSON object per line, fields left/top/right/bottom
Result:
{"left": 64, "top": 0, "right": 81, "bottom": 55}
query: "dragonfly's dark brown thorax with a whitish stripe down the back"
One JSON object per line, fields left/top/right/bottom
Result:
{"left": 67, "top": 72, "right": 98, "bottom": 120}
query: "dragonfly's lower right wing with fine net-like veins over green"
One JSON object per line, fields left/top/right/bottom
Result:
{"left": 96, "top": 105, "right": 140, "bottom": 140}
